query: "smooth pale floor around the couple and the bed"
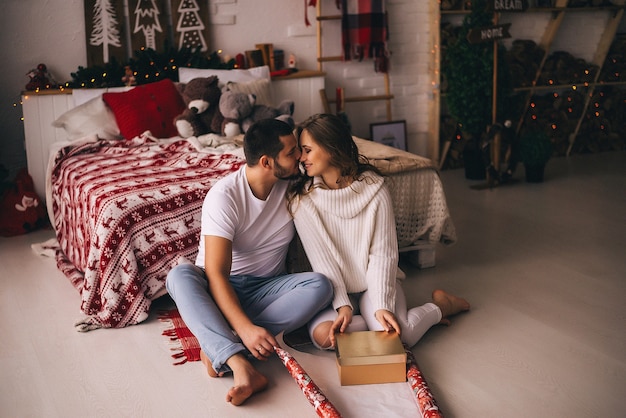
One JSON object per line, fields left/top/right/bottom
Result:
{"left": 0, "top": 152, "right": 626, "bottom": 418}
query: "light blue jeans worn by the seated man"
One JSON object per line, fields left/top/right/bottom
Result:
{"left": 165, "top": 264, "right": 333, "bottom": 373}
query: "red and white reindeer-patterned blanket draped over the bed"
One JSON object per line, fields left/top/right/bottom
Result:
{"left": 51, "top": 134, "right": 244, "bottom": 331}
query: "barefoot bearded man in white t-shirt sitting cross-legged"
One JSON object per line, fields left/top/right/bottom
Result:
{"left": 166, "top": 119, "right": 332, "bottom": 405}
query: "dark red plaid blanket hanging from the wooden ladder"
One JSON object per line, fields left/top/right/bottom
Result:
{"left": 341, "top": 0, "right": 389, "bottom": 73}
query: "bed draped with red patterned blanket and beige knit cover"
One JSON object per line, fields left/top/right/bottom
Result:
{"left": 41, "top": 68, "right": 456, "bottom": 331}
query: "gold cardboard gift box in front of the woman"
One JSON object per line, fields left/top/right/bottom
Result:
{"left": 335, "top": 331, "right": 406, "bottom": 386}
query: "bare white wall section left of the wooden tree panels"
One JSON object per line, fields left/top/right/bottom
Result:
{"left": 0, "top": 0, "right": 87, "bottom": 176}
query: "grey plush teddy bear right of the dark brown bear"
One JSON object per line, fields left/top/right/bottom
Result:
{"left": 219, "top": 90, "right": 295, "bottom": 136}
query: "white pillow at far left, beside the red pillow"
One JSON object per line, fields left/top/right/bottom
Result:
{"left": 52, "top": 95, "right": 121, "bottom": 141}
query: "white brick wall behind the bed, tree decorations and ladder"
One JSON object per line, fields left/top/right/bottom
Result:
{"left": 0, "top": 0, "right": 436, "bottom": 181}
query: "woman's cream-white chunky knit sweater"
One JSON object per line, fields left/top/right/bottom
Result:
{"left": 291, "top": 172, "right": 398, "bottom": 312}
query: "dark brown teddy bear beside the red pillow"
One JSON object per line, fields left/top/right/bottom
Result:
{"left": 174, "top": 76, "right": 223, "bottom": 138}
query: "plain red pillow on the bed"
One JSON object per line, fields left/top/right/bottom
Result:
{"left": 102, "top": 78, "right": 185, "bottom": 139}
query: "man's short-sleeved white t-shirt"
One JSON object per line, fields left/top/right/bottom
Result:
{"left": 196, "top": 165, "right": 295, "bottom": 277}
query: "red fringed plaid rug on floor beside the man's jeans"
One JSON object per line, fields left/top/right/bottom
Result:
{"left": 159, "top": 308, "right": 200, "bottom": 365}
